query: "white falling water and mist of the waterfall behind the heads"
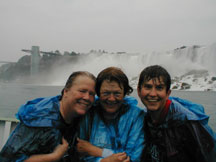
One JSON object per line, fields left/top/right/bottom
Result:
{"left": 42, "top": 43, "right": 216, "bottom": 90}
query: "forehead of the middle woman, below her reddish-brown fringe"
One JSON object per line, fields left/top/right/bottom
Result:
{"left": 100, "top": 80, "right": 123, "bottom": 90}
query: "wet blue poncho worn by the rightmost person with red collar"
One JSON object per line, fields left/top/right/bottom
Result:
{"left": 142, "top": 97, "right": 216, "bottom": 162}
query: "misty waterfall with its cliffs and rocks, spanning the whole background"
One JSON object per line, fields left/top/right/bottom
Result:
{"left": 0, "top": 43, "right": 216, "bottom": 90}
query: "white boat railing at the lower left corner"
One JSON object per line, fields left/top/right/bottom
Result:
{"left": 0, "top": 118, "right": 19, "bottom": 151}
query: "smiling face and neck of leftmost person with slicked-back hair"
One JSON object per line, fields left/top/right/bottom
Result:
{"left": 60, "top": 75, "right": 95, "bottom": 121}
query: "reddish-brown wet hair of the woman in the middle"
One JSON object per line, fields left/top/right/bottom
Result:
{"left": 96, "top": 67, "right": 133, "bottom": 96}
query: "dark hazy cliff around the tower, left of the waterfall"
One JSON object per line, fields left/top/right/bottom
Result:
{"left": 0, "top": 54, "right": 79, "bottom": 83}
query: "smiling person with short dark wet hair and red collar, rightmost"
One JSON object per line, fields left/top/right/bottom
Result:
{"left": 137, "top": 65, "right": 216, "bottom": 162}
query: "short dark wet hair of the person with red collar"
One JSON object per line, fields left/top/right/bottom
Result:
{"left": 138, "top": 65, "right": 171, "bottom": 92}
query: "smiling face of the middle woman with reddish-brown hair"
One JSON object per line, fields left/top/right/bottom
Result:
{"left": 100, "top": 80, "right": 124, "bottom": 114}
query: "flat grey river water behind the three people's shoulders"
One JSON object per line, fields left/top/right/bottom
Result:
{"left": 0, "top": 83, "right": 216, "bottom": 130}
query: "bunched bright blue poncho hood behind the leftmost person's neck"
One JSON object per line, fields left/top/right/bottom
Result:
{"left": 16, "top": 95, "right": 61, "bottom": 127}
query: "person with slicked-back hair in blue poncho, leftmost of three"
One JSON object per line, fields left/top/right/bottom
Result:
{"left": 0, "top": 71, "right": 95, "bottom": 162}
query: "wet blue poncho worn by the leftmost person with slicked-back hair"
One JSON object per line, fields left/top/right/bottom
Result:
{"left": 0, "top": 96, "right": 78, "bottom": 162}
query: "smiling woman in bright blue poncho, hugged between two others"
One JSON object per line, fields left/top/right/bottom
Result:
{"left": 77, "top": 67, "right": 144, "bottom": 162}
